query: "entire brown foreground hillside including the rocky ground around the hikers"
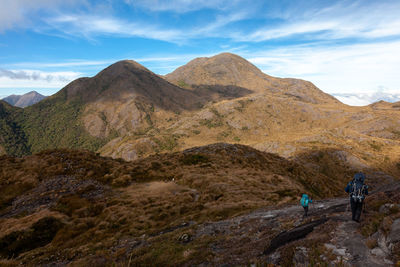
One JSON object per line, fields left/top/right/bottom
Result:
{"left": 0, "top": 146, "right": 400, "bottom": 266}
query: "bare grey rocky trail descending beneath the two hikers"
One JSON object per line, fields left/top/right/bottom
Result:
{"left": 187, "top": 173, "right": 399, "bottom": 266}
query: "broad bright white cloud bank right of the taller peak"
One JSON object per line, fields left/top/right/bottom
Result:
{"left": 244, "top": 41, "right": 400, "bottom": 97}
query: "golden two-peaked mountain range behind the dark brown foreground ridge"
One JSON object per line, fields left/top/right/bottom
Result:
{"left": 1, "top": 53, "right": 400, "bottom": 179}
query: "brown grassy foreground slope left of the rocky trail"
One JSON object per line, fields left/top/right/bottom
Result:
{"left": 0, "top": 143, "right": 351, "bottom": 265}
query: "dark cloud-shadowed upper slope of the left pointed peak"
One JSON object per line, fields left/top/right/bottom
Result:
{"left": 63, "top": 60, "right": 201, "bottom": 111}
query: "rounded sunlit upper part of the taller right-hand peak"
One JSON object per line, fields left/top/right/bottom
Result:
{"left": 165, "top": 53, "right": 339, "bottom": 103}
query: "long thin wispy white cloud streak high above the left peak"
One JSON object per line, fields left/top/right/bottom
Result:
{"left": 46, "top": 8, "right": 249, "bottom": 44}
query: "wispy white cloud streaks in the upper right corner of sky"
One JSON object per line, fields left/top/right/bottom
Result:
{"left": 232, "top": 1, "right": 400, "bottom": 42}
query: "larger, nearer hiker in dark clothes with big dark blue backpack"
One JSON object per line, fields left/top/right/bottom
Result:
{"left": 345, "top": 172, "right": 368, "bottom": 222}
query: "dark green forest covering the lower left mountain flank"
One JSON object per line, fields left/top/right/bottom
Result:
{"left": 0, "top": 90, "right": 110, "bottom": 156}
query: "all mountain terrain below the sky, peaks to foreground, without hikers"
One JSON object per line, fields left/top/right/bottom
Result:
{"left": 0, "top": 54, "right": 400, "bottom": 266}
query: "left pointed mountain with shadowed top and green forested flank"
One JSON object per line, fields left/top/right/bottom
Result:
{"left": 14, "top": 61, "right": 208, "bottom": 152}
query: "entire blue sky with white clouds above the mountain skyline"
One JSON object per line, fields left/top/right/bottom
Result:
{"left": 0, "top": 0, "right": 400, "bottom": 105}
